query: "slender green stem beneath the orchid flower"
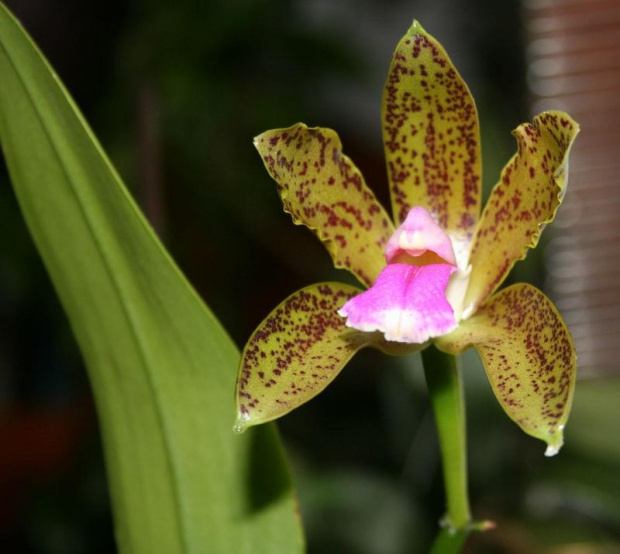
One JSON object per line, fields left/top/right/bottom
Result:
{"left": 422, "top": 346, "right": 472, "bottom": 554}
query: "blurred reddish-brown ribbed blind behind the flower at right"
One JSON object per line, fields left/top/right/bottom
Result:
{"left": 524, "top": 0, "right": 620, "bottom": 376}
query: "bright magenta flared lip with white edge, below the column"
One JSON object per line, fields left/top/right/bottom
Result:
{"left": 338, "top": 263, "right": 457, "bottom": 344}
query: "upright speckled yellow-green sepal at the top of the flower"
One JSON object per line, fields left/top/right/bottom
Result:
{"left": 382, "top": 21, "right": 481, "bottom": 250}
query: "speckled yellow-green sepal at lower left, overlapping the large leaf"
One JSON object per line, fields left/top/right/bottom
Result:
{"left": 235, "top": 283, "right": 420, "bottom": 431}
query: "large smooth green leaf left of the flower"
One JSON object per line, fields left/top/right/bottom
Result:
{"left": 0, "top": 5, "right": 302, "bottom": 554}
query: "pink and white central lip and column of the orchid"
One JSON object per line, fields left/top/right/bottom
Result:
{"left": 338, "top": 207, "right": 470, "bottom": 344}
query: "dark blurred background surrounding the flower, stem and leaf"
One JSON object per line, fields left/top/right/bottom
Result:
{"left": 0, "top": 0, "right": 620, "bottom": 554}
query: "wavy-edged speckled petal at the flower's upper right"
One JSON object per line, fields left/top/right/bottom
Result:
{"left": 464, "top": 112, "right": 579, "bottom": 311}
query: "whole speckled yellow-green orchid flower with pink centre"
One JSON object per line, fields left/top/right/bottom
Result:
{"left": 236, "top": 22, "right": 578, "bottom": 455}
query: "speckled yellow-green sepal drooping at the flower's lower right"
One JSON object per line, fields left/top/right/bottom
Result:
{"left": 436, "top": 283, "right": 577, "bottom": 456}
